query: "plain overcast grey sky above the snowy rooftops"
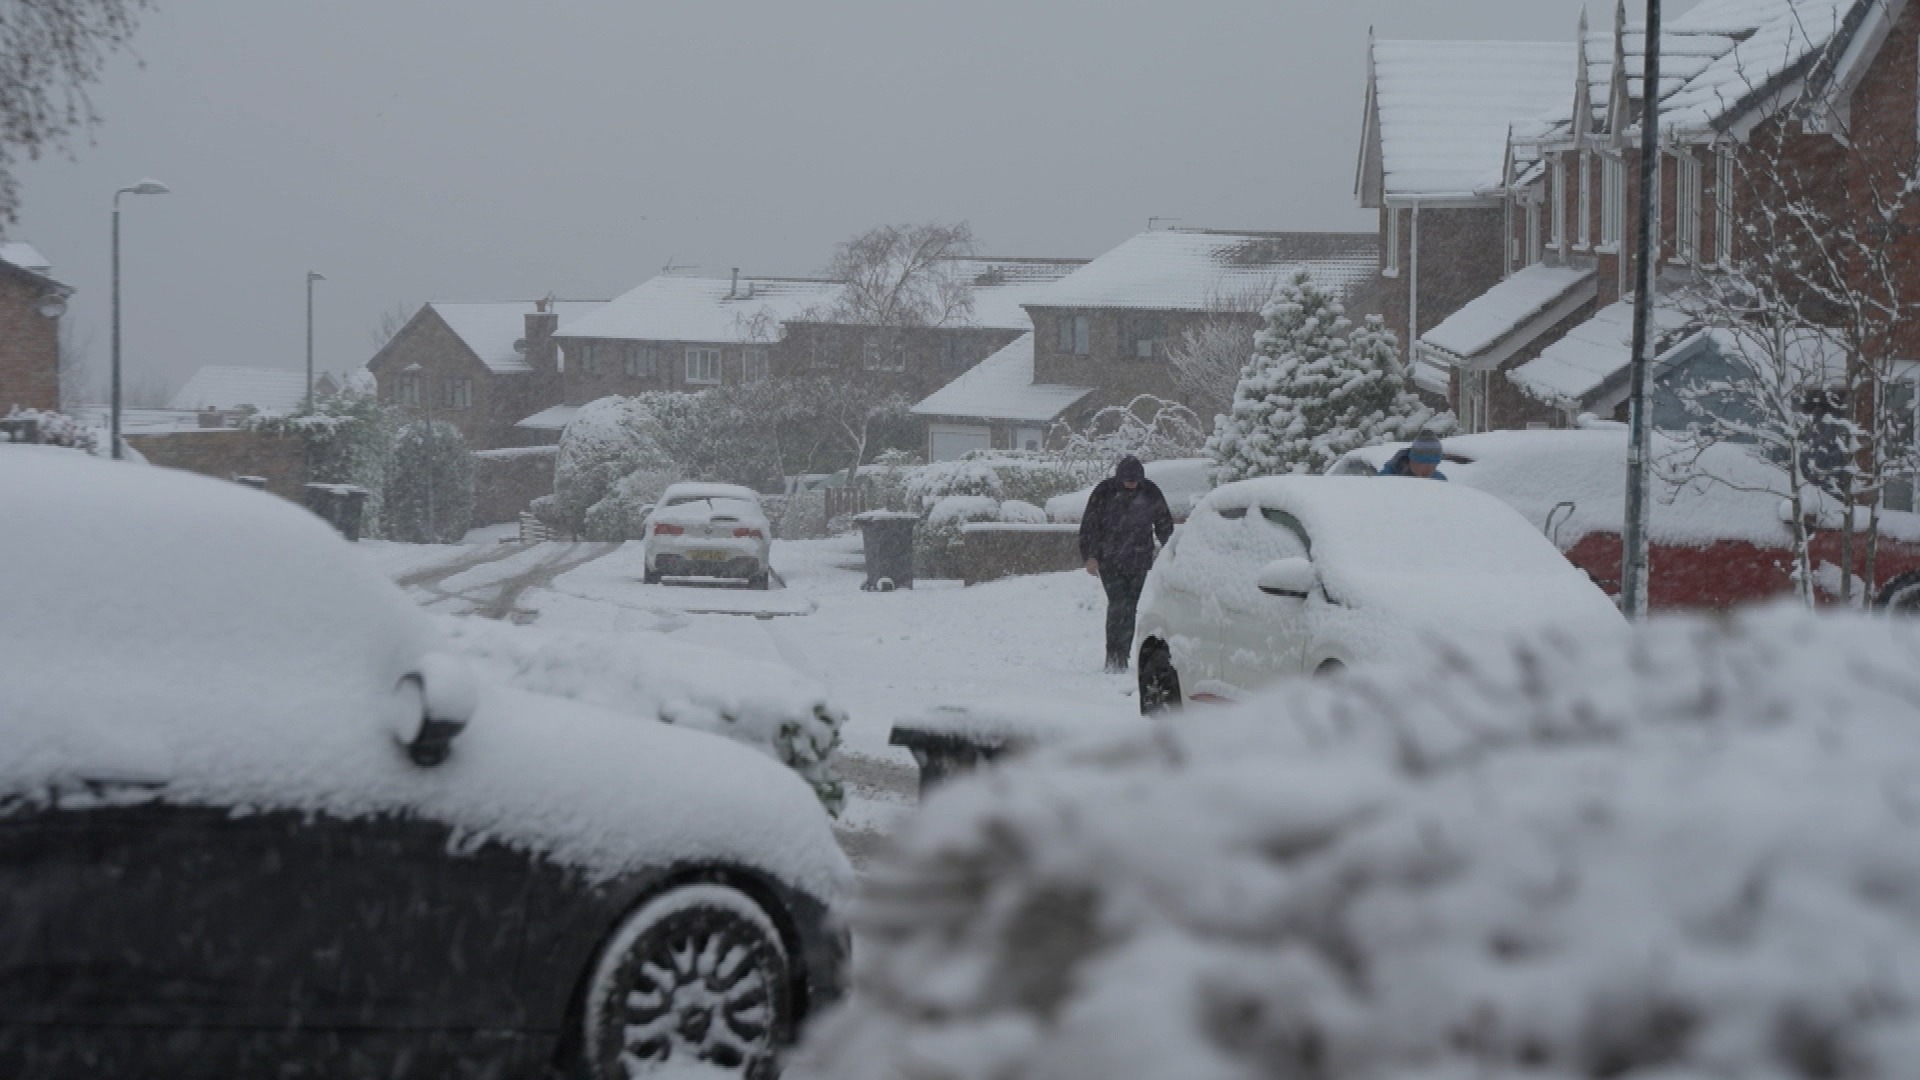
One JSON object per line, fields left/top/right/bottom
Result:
{"left": 13, "top": 0, "right": 1692, "bottom": 395}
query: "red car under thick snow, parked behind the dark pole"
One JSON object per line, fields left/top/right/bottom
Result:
{"left": 1331, "top": 427, "right": 1920, "bottom": 613}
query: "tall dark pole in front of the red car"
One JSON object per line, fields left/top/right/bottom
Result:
{"left": 1620, "top": 0, "right": 1661, "bottom": 619}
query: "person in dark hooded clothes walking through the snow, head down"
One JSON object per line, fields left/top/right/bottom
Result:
{"left": 1081, "top": 455, "right": 1173, "bottom": 673}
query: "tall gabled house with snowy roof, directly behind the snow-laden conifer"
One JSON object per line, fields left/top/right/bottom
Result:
{"left": 1354, "top": 40, "right": 1576, "bottom": 398}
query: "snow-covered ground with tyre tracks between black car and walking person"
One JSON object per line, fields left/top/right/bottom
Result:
{"left": 361, "top": 536, "right": 1137, "bottom": 857}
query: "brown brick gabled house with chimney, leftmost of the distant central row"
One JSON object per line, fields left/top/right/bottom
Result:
{"left": 367, "top": 300, "right": 605, "bottom": 450}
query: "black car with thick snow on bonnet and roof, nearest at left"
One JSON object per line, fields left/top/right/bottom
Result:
{"left": 0, "top": 448, "right": 851, "bottom": 1080}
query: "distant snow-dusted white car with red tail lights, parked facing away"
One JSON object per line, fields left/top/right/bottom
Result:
{"left": 641, "top": 484, "right": 774, "bottom": 588}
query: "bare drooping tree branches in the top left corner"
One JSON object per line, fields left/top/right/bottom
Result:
{"left": 0, "top": 0, "right": 152, "bottom": 225}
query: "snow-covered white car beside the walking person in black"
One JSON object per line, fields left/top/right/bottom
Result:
{"left": 1135, "top": 477, "right": 1624, "bottom": 711}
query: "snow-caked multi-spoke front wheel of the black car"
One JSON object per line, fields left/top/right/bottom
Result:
{"left": 582, "top": 884, "right": 793, "bottom": 1080}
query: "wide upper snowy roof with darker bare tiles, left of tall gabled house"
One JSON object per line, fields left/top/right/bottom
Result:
{"left": 1029, "top": 229, "right": 1380, "bottom": 311}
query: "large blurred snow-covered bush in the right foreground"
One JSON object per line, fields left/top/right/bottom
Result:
{"left": 801, "top": 609, "right": 1920, "bottom": 1080}
